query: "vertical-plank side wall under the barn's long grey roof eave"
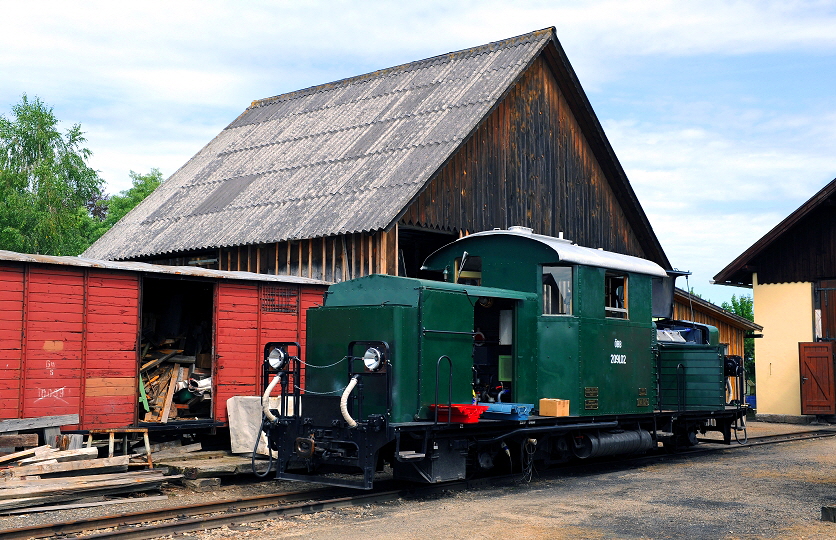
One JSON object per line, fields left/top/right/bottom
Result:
{"left": 217, "top": 226, "right": 398, "bottom": 282}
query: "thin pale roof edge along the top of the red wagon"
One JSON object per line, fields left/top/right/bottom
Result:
{"left": 0, "top": 249, "right": 331, "bottom": 285}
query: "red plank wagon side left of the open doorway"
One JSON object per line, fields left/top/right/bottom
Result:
{"left": 0, "top": 264, "right": 139, "bottom": 429}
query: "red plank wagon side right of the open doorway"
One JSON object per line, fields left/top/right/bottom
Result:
{"left": 212, "top": 283, "right": 326, "bottom": 422}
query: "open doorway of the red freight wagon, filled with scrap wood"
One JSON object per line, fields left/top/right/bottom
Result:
{"left": 138, "top": 277, "right": 214, "bottom": 424}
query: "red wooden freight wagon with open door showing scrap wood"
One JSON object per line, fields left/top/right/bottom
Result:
{"left": 0, "top": 250, "right": 328, "bottom": 429}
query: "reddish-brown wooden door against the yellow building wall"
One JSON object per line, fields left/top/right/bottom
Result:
{"left": 798, "top": 342, "right": 836, "bottom": 414}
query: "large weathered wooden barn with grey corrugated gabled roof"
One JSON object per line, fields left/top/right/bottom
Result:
{"left": 85, "top": 28, "right": 671, "bottom": 282}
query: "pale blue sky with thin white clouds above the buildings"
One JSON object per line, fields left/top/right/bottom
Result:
{"left": 0, "top": 0, "right": 836, "bottom": 304}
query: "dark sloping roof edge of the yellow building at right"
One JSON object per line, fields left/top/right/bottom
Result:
{"left": 714, "top": 179, "right": 836, "bottom": 286}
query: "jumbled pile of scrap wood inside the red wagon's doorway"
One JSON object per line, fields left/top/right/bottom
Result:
{"left": 139, "top": 340, "right": 211, "bottom": 423}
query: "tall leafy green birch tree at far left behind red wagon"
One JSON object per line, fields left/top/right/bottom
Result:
{"left": 0, "top": 94, "right": 103, "bottom": 255}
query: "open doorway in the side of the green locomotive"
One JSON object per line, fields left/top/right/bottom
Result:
{"left": 473, "top": 297, "right": 516, "bottom": 403}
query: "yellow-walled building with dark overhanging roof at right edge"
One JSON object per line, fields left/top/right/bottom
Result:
{"left": 714, "top": 180, "right": 836, "bottom": 416}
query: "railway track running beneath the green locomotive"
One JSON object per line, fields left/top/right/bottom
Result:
{"left": 0, "top": 429, "right": 836, "bottom": 540}
